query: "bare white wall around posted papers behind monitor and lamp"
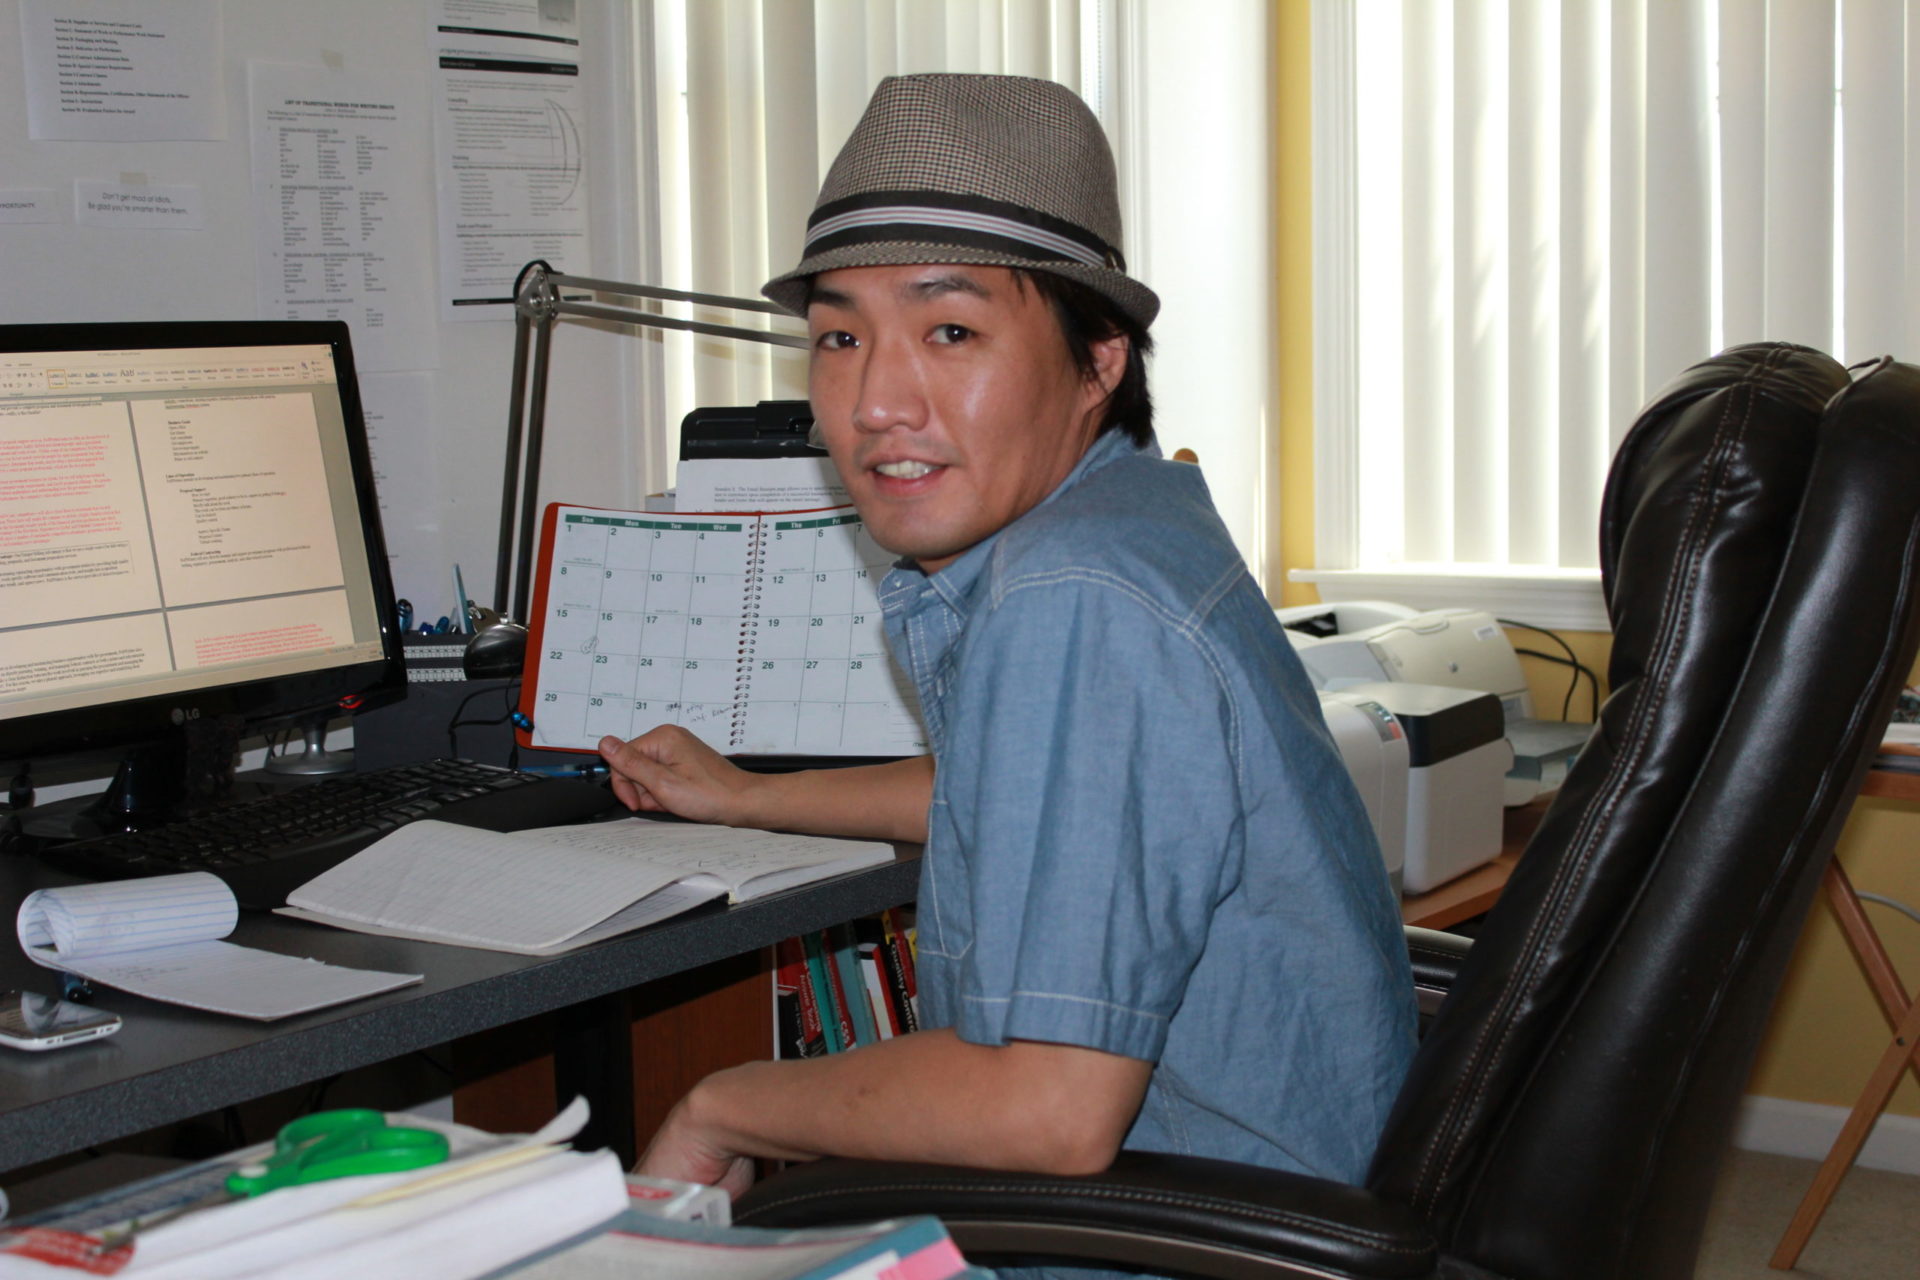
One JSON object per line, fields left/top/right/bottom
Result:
{"left": 0, "top": 0, "right": 664, "bottom": 612}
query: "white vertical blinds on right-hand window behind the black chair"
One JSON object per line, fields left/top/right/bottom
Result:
{"left": 1306, "top": 0, "right": 1920, "bottom": 610}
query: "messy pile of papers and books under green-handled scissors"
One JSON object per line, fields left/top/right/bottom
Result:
{"left": 0, "top": 1100, "right": 991, "bottom": 1280}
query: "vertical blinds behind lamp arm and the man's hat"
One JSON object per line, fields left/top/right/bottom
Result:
{"left": 641, "top": 0, "right": 1108, "bottom": 437}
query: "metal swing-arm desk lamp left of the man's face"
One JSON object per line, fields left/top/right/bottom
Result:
{"left": 474, "top": 259, "right": 808, "bottom": 679}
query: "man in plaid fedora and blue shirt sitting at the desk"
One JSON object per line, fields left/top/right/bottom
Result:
{"left": 601, "top": 75, "right": 1413, "bottom": 1228}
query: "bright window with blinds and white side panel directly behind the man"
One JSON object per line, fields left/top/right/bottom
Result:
{"left": 636, "top": 0, "right": 1273, "bottom": 574}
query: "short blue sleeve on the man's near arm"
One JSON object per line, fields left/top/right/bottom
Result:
{"left": 935, "top": 572, "right": 1244, "bottom": 1061}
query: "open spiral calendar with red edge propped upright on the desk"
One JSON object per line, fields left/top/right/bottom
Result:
{"left": 518, "top": 505, "right": 927, "bottom": 756}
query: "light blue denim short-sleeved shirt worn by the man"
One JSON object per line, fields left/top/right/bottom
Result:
{"left": 881, "top": 432, "right": 1415, "bottom": 1205}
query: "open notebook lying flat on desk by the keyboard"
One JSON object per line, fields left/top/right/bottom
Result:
{"left": 282, "top": 818, "right": 893, "bottom": 956}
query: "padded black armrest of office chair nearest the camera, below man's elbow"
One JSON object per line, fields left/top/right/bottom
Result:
{"left": 733, "top": 1151, "right": 1438, "bottom": 1280}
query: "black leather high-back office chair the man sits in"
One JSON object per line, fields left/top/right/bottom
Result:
{"left": 735, "top": 344, "right": 1920, "bottom": 1280}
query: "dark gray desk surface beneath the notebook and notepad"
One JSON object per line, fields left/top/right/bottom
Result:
{"left": 0, "top": 844, "right": 920, "bottom": 1171}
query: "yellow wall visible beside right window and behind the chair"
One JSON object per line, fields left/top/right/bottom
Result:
{"left": 1269, "top": 0, "right": 1920, "bottom": 1115}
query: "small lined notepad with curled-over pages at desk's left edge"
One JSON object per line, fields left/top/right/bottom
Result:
{"left": 17, "top": 871, "right": 420, "bottom": 1021}
